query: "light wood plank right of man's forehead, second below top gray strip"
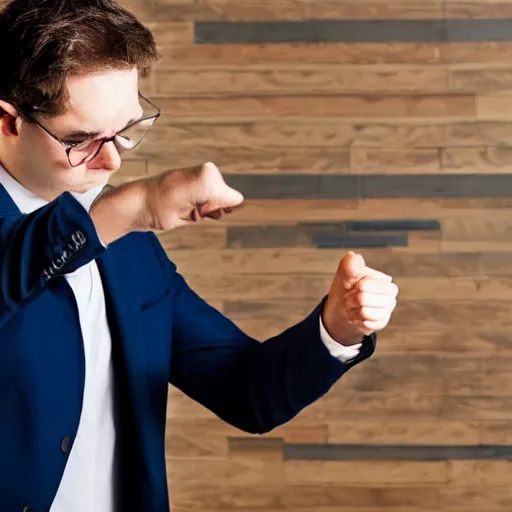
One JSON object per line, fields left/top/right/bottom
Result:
{"left": 146, "top": 63, "right": 448, "bottom": 98}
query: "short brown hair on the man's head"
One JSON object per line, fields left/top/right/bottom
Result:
{"left": 0, "top": 0, "right": 159, "bottom": 117}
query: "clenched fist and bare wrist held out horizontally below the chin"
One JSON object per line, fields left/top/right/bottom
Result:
{"left": 89, "top": 163, "right": 244, "bottom": 244}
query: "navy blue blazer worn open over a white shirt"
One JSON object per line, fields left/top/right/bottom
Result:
{"left": 0, "top": 186, "right": 375, "bottom": 512}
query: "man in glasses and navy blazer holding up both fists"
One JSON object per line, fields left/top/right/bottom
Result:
{"left": 0, "top": 0, "right": 397, "bottom": 512}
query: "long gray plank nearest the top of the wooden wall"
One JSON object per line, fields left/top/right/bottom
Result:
{"left": 195, "top": 18, "right": 512, "bottom": 44}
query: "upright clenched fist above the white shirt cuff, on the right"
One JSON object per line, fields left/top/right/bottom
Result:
{"left": 322, "top": 252, "right": 398, "bottom": 345}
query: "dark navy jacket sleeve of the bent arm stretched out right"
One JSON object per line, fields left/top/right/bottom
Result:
{"left": 148, "top": 234, "right": 376, "bottom": 433}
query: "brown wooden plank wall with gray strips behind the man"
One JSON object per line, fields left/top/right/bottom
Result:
{"left": 109, "top": 0, "right": 512, "bottom": 512}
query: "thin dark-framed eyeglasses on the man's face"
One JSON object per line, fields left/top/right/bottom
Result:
{"left": 21, "top": 93, "right": 161, "bottom": 167}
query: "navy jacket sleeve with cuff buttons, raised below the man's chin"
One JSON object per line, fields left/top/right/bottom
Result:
{"left": 0, "top": 192, "right": 105, "bottom": 327}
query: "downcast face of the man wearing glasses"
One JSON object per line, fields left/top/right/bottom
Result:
{"left": 0, "top": 69, "right": 143, "bottom": 200}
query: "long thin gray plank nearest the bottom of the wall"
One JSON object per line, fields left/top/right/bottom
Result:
{"left": 284, "top": 444, "right": 512, "bottom": 461}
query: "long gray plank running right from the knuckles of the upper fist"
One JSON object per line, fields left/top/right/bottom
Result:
{"left": 224, "top": 174, "right": 512, "bottom": 199}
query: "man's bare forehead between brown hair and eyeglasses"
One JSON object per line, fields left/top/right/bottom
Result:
{"left": 55, "top": 69, "right": 142, "bottom": 131}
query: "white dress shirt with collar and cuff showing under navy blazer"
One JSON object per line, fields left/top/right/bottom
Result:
{"left": 0, "top": 165, "right": 362, "bottom": 512}
